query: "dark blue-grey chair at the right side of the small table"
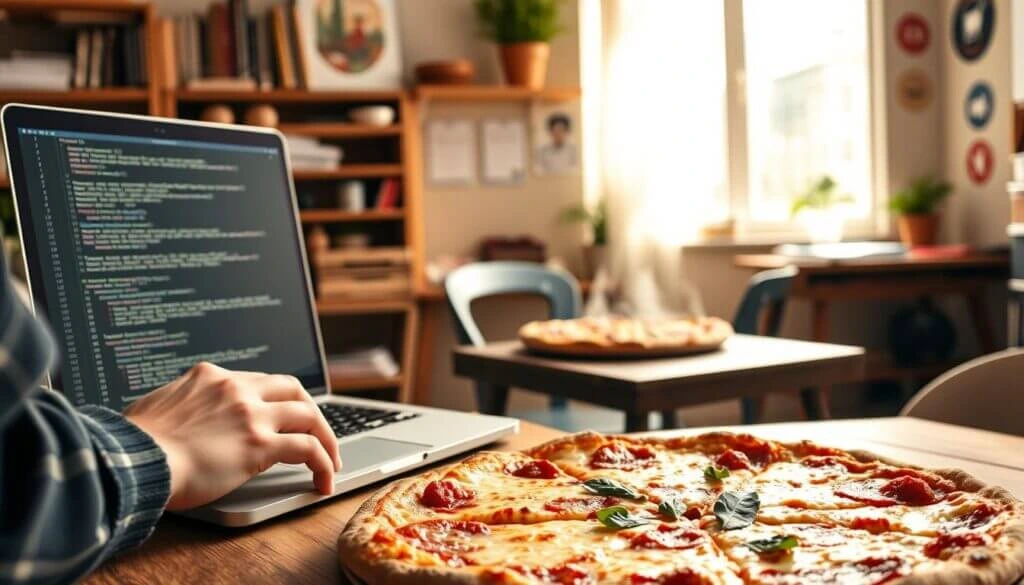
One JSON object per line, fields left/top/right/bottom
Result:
{"left": 732, "top": 266, "right": 827, "bottom": 424}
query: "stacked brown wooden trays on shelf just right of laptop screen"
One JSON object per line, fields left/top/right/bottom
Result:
{"left": 309, "top": 247, "right": 413, "bottom": 300}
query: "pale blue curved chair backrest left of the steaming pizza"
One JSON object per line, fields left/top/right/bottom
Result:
{"left": 444, "top": 261, "right": 583, "bottom": 345}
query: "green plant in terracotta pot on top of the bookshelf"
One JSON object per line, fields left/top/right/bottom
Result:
{"left": 475, "top": 0, "right": 562, "bottom": 89}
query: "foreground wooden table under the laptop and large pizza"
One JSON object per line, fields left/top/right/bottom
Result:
{"left": 85, "top": 418, "right": 1024, "bottom": 585}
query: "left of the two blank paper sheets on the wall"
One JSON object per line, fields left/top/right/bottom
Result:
{"left": 426, "top": 120, "right": 476, "bottom": 184}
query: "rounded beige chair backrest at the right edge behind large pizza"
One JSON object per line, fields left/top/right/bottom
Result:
{"left": 900, "top": 349, "right": 1024, "bottom": 435}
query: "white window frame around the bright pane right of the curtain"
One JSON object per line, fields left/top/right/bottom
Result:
{"left": 722, "top": 0, "right": 892, "bottom": 241}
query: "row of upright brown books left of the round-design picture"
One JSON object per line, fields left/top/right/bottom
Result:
{"left": 174, "top": 0, "right": 309, "bottom": 90}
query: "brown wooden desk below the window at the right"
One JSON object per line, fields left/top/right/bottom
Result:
{"left": 733, "top": 252, "right": 1010, "bottom": 379}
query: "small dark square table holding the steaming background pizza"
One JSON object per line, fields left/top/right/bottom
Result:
{"left": 454, "top": 335, "right": 864, "bottom": 432}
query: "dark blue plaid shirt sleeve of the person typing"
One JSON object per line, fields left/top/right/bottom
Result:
{"left": 0, "top": 276, "right": 170, "bottom": 585}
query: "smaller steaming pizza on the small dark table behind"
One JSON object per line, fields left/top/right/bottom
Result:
{"left": 519, "top": 317, "right": 733, "bottom": 356}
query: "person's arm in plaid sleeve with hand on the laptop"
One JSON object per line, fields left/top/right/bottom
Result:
{"left": 0, "top": 282, "right": 341, "bottom": 584}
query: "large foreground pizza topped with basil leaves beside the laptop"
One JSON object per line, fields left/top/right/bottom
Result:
{"left": 339, "top": 432, "right": 1024, "bottom": 585}
